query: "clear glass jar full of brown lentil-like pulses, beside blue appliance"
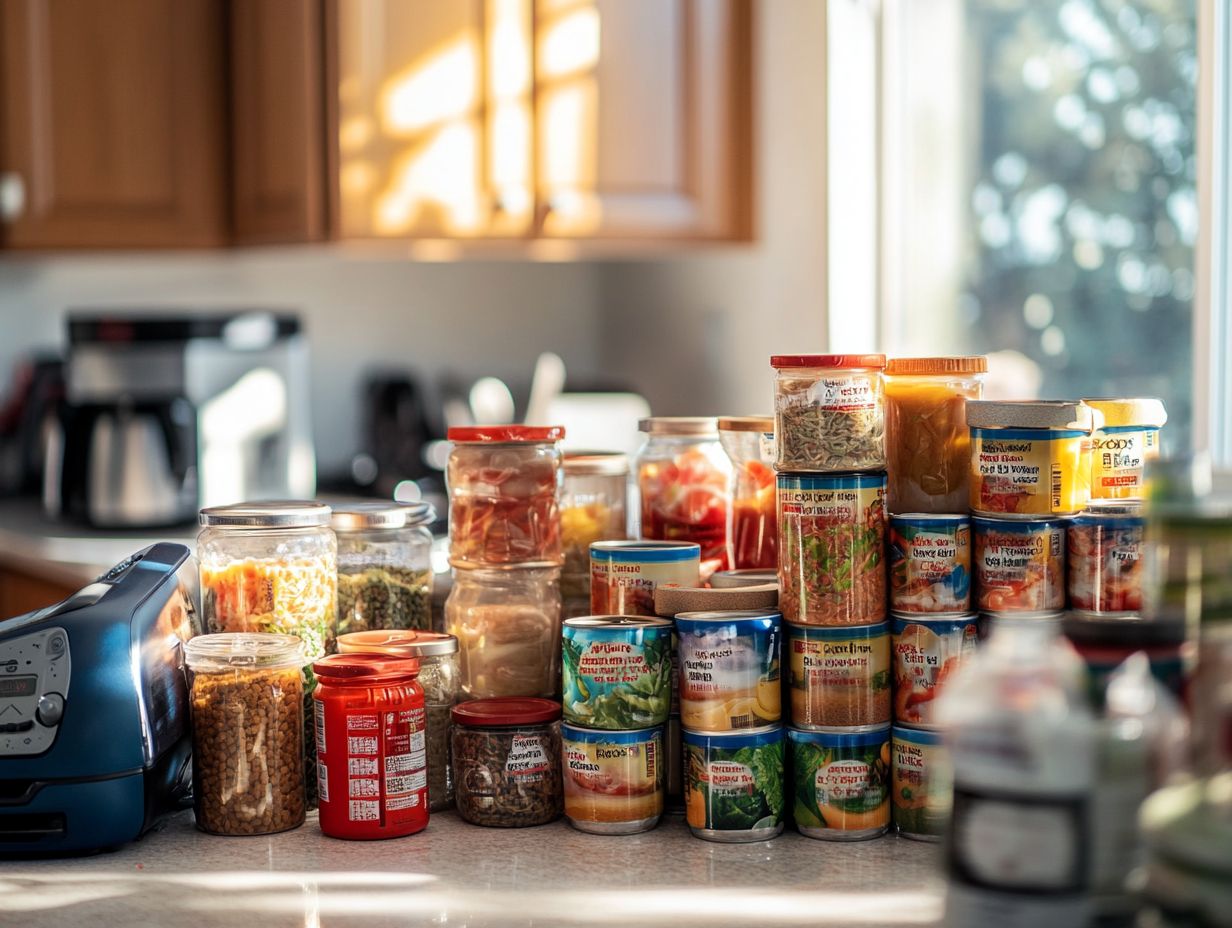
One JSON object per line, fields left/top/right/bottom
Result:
{"left": 185, "top": 633, "right": 308, "bottom": 834}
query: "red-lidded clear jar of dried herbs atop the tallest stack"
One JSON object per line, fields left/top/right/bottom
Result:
{"left": 770, "top": 355, "right": 886, "bottom": 473}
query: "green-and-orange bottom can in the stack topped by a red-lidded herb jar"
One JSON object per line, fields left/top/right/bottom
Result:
{"left": 787, "top": 725, "right": 890, "bottom": 840}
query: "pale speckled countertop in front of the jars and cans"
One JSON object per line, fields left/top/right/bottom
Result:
{"left": 0, "top": 812, "right": 941, "bottom": 928}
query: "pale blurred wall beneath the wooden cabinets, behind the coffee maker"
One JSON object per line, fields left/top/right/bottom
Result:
{"left": 0, "top": 248, "right": 598, "bottom": 472}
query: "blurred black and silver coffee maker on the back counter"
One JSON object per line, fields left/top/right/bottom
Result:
{"left": 43, "top": 311, "right": 315, "bottom": 529}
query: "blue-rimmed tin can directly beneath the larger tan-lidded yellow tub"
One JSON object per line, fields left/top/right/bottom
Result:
{"left": 971, "top": 516, "right": 1068, "bottom": 613}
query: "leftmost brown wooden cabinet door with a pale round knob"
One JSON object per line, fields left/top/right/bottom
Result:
{"left": 0, "top": 0, "right": 228, "bottom": 248}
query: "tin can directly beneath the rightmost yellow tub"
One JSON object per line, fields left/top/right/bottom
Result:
{"left": 1067, "top": 503, "right": 1147, "bottom": 613}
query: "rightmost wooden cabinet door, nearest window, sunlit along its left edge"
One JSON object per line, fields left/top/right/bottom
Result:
{"left": 535, "top": 0, "right": 752, "bottom": 239}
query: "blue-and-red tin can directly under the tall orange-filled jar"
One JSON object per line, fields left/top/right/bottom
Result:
{"left": 890, "top": 513, "right": 971, "bottom": 614}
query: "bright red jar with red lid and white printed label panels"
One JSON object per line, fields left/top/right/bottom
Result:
{"left": 313, "top": 654, "right": 428, "bottom": 840}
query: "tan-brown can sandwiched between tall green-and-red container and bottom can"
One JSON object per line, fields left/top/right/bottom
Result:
{"left": 786, "top": 622, "right": 891, "bottom": 728}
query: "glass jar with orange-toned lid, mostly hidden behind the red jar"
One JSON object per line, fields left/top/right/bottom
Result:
{"left": 338, "top": 629, "right": 462, "bottom": 812}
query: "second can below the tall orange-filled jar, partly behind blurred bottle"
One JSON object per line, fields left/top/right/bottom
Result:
{"left": 890, "top": 615, "right": 979, "bottom": 726}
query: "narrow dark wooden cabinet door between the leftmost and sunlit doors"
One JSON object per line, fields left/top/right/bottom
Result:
{"left": 230, "top": 0, "right": 326, "bottom": 245}
